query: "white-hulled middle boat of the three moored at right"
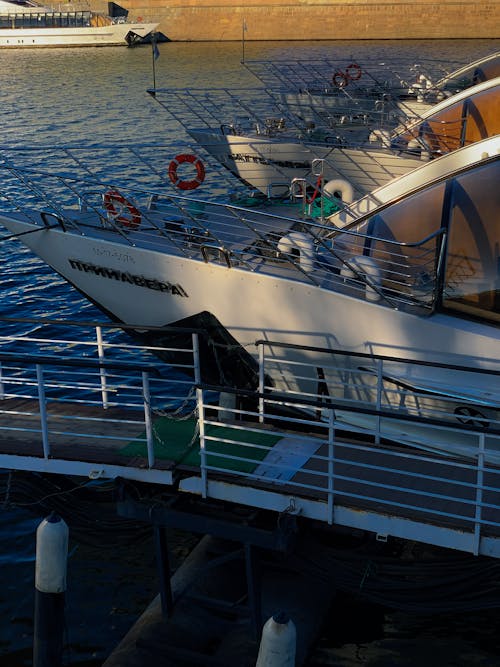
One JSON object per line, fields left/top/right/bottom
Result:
{"left": 182, "top": 77, "right": 500, "bottom": 198}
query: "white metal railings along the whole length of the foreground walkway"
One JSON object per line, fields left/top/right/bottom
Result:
{"left": 0, "top": 323, "right": 500, "bottom": 557}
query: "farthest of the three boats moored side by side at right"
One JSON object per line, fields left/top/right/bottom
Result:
{"left": 243, "top": 52, "right": 500, "bottom": 124}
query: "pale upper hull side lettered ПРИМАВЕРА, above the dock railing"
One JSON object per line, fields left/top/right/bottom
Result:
{"left": 0, "top": 215, "right": 500, "bottom": 374}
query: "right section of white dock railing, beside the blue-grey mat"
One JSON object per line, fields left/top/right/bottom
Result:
{"left": 190, "top": 343, "right": 500, "bottom": 556}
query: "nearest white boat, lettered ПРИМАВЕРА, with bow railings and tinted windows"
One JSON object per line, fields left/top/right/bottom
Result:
{"left": 0, "top": 135, "right": 500, "bottom": 461}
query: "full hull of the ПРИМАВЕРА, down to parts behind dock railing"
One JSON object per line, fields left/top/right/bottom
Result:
{"left": 0, "top": 214, "right": 500, "bottom": 461}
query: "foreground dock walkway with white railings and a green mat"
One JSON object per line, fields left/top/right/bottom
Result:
{"left": 0, "top": 320, "right": 500, "bottom": 557}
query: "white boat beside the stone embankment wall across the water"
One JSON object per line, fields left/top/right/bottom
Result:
{"left": 0, "top": 0, "right": 159, "bottom": 48}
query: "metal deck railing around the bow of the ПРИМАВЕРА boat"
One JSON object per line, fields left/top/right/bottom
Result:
{"left": 0, "top": 166, "right": 443, "bottom": 318}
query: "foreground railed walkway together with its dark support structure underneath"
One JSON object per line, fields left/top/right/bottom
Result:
{"left": 0, "top": 320, "right": 500, "bottom": 667}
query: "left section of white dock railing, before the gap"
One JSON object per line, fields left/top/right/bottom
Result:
{"left": 0, "top": 321, "right": 199, "bottom": 480}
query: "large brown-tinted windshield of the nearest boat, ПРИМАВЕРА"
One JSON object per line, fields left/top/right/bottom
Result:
{"left": 334, "top": 157, "right": 500, "bottom": 323}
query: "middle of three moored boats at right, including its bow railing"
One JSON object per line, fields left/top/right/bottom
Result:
{"left": 160, "top": 77, "right": 500, "bottom": 202}
